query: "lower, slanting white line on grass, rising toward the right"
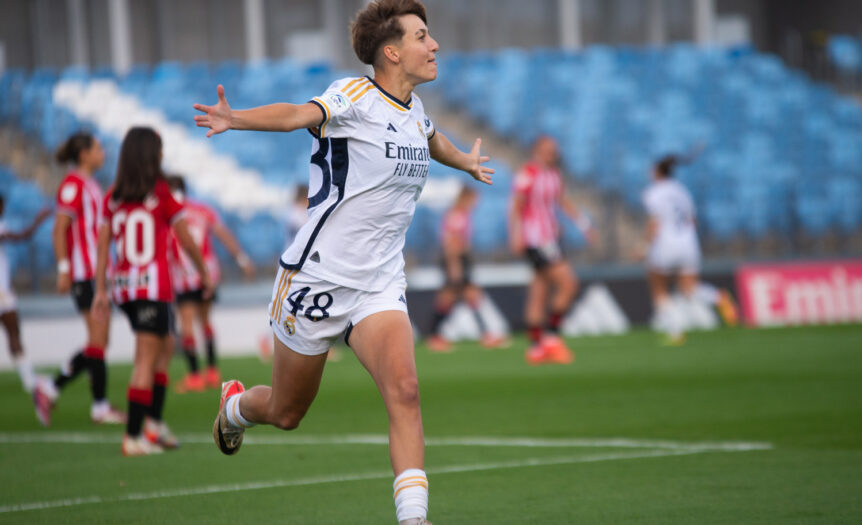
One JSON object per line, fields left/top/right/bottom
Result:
{"left": 0, "top": 449, "right": 748, "bottom": 514}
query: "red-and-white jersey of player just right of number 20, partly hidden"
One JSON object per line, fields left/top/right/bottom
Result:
{"left": 170, "top": 200, "right": 221, "bottom": 293}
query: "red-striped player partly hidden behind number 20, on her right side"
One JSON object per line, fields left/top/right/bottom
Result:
{"left": 167, "top": 176, "right": 255, "bottom": 393}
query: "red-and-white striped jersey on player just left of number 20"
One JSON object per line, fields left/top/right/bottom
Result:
{"left": 57, "top": 171, "right": 102, "bottom": 281}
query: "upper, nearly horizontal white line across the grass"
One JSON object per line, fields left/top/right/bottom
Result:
{"left": 0, "top": 432, "right": 772, "bottom": 452}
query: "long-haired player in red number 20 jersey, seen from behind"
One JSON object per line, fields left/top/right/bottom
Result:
{"left": 93, "top": 128, "right": 212, "bottom": 456}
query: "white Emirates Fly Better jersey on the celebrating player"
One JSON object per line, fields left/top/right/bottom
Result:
{"left": 280, "top": 77, "right": 435, "bottom": 292}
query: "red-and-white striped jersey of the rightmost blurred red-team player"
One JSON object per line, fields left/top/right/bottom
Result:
{"left": 515, "top": 163, "right": 562, "bottom": 248}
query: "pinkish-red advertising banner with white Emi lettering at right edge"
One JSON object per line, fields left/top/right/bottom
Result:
{"left": 736, "top": 261, "right": 862, "bottom": 326}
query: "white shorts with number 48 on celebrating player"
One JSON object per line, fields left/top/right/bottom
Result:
{"left": 269, "top": 268, "right": 407, "bottom": 355}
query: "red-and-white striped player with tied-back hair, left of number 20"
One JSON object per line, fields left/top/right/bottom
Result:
{"left": 33, "top": 133, "right": 126, "bottom": 426}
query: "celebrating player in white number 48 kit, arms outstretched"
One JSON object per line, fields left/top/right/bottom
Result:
{"left": 195, "top": 0, "right": 493, "bottom": 525}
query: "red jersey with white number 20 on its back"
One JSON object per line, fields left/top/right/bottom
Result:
{"left": 102, "top": 179, "right": 184, "bottom": 304}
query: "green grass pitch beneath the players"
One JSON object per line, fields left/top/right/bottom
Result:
{"left": 0, "top": 325, "right": 862, "bottom": 525}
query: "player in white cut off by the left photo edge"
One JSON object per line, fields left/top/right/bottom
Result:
{"left": 0, "top": 196, "right": 51, "bottom": 393}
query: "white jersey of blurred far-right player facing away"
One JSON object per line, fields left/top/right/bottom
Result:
{"left": 643, "top": 179, "right": 700, "bottom": 271}
